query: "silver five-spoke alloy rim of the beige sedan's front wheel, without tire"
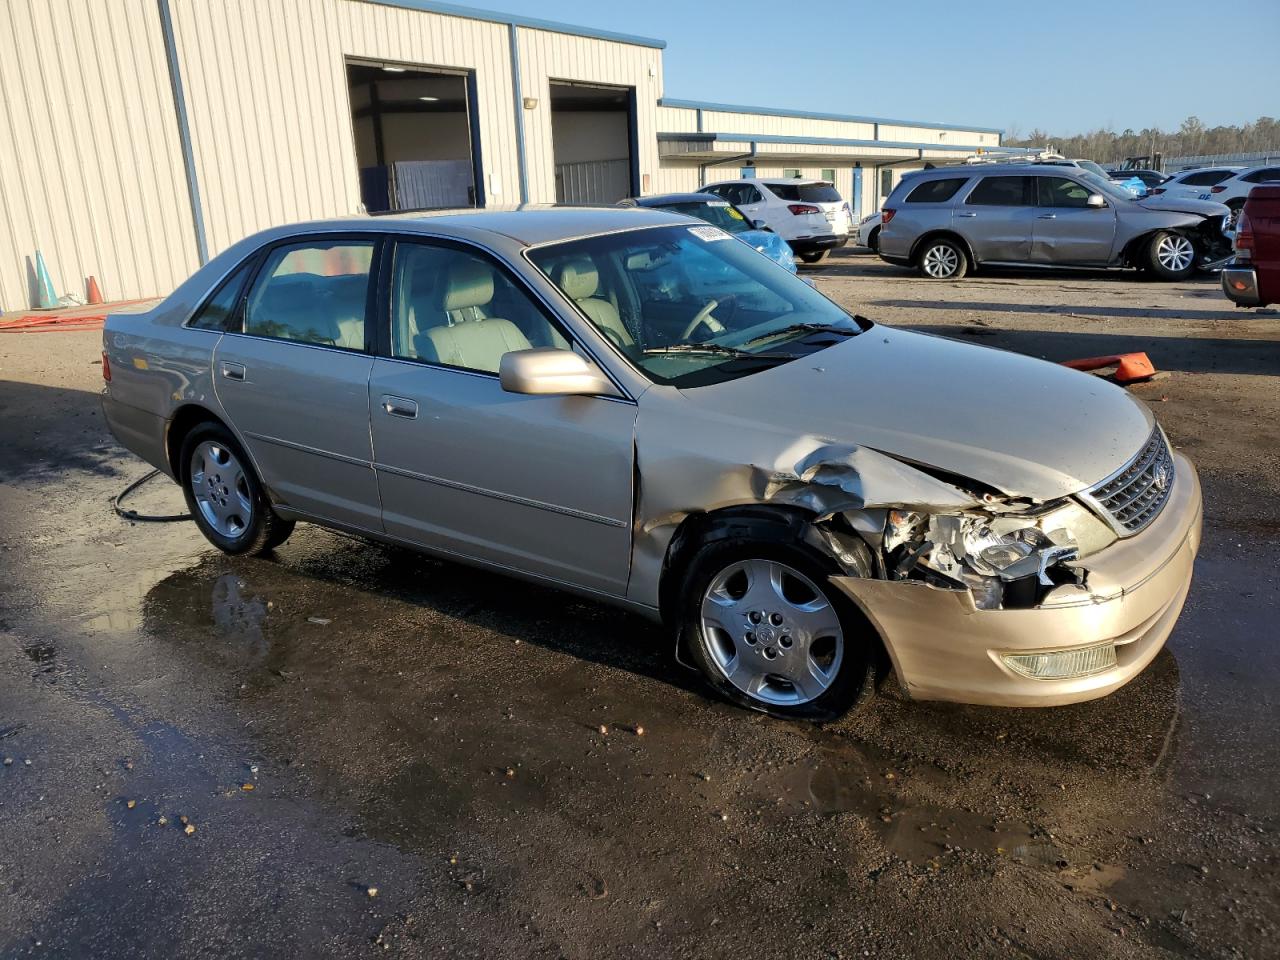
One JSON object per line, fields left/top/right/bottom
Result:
{"left": 701, "top": 559, "right": 845, "bottom": 705}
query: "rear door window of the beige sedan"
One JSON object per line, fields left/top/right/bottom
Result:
{"left": 244, "top": 239, "right": 374, "bottom": 349}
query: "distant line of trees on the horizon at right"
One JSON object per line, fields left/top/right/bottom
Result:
{"left": 1004, "top": 116, "right": 1280, "bottom": 164}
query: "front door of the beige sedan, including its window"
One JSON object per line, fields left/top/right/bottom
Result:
{"left": 370, "top": 241, "right": 636, "bottom": 595}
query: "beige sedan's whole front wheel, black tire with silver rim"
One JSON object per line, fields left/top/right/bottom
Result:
{"left": 680, "top": 531, "right": 877, "bottom": 721}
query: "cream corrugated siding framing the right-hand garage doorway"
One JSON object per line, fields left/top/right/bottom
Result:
{"left": 518, "top": 27, "right": 662, "bottom": 202}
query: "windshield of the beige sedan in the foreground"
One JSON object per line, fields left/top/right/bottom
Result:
{"left": 527, "top": 224, "right": 869, "bottom": 387}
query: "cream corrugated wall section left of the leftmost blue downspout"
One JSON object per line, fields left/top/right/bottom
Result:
{"left": 0, "top": 0, "right": 196, "bottom": 310}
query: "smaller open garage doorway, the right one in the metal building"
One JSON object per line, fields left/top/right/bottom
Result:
{"left": 550, "top": 81, "right": 640, "bottom": 204}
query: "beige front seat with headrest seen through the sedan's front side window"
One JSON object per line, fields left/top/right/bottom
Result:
{"left": 413, "top": 261, "right": 530, "bottom": 374}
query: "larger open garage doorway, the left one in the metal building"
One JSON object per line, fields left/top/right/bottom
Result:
{"left": 347, "top": 60, "right": 484, "bottom": 214}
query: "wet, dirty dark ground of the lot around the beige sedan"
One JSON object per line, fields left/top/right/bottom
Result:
{"left": 0, "top": 253, "right": 1280, "bottom": 957}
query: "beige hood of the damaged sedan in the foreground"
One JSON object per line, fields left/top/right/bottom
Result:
{"left": 684, "top": 325, "right": 1155, "bottom": 500}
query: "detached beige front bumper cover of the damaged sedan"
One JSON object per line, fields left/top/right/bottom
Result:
{"left": 831, "top": 453, "right": 1203, "bottom": 707}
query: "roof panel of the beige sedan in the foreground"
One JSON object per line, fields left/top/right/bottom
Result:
{"left": 266, "top": 204, "right": 687, "bottom": 247}
